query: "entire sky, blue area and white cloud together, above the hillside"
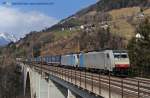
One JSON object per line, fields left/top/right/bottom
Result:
{"left": 0, "top": 0, "right": 96, "bottom": 38}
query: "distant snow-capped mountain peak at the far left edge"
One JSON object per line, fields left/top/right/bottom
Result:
{"left": 0, "top": 33, "right": 17, "bottom": 46}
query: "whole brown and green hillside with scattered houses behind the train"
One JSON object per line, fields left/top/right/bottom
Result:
{"left": 5, "top": 0, "right": 150, "bottom": 56}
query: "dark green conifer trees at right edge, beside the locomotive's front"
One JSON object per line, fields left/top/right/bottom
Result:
{"left": 128, "top": 19, "right": 150, "bottom": 73}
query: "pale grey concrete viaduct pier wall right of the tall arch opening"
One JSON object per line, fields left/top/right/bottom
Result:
{"left": 28, "top": 70, "right": 67, "bottom": 98}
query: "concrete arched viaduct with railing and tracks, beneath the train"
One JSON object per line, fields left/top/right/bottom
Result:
{"left": 18, "top": 62, "right": 150, "bottom": 98}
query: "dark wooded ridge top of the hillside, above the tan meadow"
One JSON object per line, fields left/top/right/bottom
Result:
{"left": 76, "top": 0, "right": 150, "bottom": 16}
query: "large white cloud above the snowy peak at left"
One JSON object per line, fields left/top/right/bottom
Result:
{"left": 0, "top": 6, "right": 57, "bottom": 38}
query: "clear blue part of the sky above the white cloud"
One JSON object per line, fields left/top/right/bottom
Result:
{"left": 5, "top": 0, "right": 96, "bottom": 19}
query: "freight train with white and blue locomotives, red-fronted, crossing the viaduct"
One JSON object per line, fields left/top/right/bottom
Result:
{"left": 28, "top": 50, "right": 130, "bottom": 75}
